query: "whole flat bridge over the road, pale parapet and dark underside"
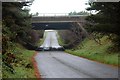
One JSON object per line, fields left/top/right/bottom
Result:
{"left": 32, "top": 15, "right": 86, "bottom": 30}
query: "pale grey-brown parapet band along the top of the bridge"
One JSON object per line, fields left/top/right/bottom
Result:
{"left": 32, "top": 15, "right": 86, "bottom": 23}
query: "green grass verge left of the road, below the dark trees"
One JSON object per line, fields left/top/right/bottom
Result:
{"left": 3, "top": 44, "right": 36, "bottom": 78}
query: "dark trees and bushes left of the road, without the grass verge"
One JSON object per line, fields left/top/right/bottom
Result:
{"left": 2, "top": 2, "right": 44, "bottom": 73}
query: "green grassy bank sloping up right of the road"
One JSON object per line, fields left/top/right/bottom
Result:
{"left": 65, "top": 37, "right": 119, "bottom": 66}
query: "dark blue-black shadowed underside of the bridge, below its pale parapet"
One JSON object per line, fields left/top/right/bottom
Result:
{"left": 32, "top": 22, "right": 72, "bottom": 30}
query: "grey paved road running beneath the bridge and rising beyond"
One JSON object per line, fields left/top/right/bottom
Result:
{"left": 35, "top": 31, "right": 118, "bottom": 78}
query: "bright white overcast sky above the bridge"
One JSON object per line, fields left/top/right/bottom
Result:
{"left": 30, "top": 0, "right": 89, "bottom": 15}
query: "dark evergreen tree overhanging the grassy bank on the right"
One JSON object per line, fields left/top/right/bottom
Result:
{"left": 86, "top": 2, "right": 120, "bottom": 50}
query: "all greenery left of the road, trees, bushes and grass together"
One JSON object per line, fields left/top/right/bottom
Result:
{"left": 2, "top": 0, "right": 43, "bottom": 78}
